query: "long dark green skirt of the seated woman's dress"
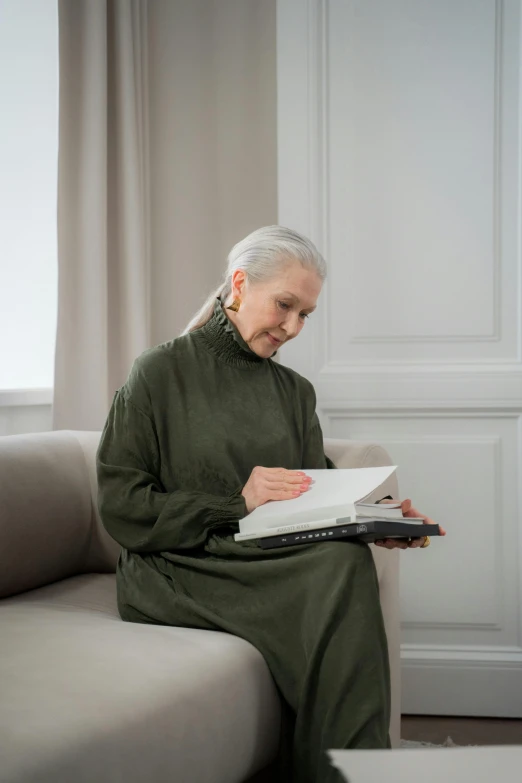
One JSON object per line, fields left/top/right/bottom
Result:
{"left": 117, "top": 530, "right": 390, "bottom": 783}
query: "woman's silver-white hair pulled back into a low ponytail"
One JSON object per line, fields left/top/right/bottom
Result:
{"left": 181, "top": 226, "right": 326, "bottom": 335}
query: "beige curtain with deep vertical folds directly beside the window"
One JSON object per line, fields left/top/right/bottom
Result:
{"left": 52, "top": 0, "right": 151, "bottom": 430}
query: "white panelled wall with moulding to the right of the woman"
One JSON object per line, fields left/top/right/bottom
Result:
{"left": 278, "top": 0, "right": 522, "bottom": 717}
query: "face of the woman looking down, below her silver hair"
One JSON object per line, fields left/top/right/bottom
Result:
{"left": 226, "top": 261, "right": 322, "bottom": 359}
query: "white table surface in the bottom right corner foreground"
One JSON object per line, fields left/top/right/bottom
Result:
{"left": 328, "top": 737, "right": 522, "bottom": 783}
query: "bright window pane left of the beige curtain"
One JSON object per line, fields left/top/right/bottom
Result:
{"left": 0, "top": 0, "right": 58, "bottom": 390}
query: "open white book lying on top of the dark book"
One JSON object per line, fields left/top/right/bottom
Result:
{"left": 234, "top": 465, "right": 423, "bottom": 541}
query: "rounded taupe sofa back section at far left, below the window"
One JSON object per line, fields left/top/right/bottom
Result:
{"left": 0, "top": 430, "right": 119, "bottom": 597}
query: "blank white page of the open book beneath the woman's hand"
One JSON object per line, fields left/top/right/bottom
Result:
{"left": 239, "top": 465, "right": 397, "bottom": 533}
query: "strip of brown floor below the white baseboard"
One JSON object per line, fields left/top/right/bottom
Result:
{"left": 401, "top": 715, "right": 522, "bottom": 745}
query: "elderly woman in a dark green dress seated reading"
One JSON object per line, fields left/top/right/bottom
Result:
{"left": 97, "top": 226, "right": 438, "bottom": 783}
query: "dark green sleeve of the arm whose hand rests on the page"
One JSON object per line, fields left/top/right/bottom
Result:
{"left": 96, "top": 390, "right": 247, "bottom": 553}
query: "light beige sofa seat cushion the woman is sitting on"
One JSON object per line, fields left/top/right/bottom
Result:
{"left": 0, "top": 574, "right": 280, "bottom": 783}
